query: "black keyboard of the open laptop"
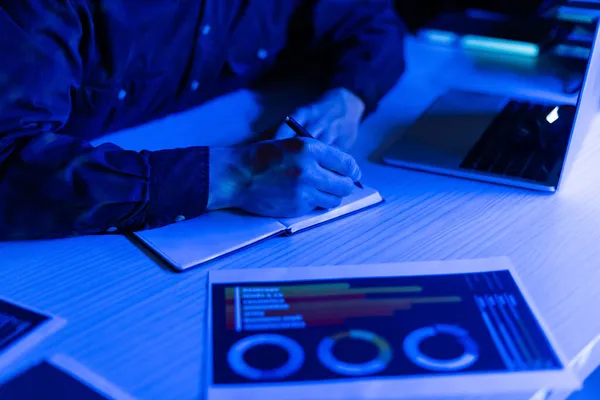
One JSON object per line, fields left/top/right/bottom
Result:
{"left": 460, "top": 101, "right": 572, "bottom": 182}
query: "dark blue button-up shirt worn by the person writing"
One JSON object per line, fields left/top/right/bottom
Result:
{"left": 0, "top": 0, "right": 404, "bottom": 240}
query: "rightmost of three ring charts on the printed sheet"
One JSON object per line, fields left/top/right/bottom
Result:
{"left": 403, "top": 324, "right": 479, "bottom": 372}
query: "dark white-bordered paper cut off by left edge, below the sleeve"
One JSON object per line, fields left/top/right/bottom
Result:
{"left": 0, "top": 298, "right": 65, "bottom": 371}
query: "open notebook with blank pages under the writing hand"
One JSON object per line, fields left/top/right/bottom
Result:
{"left": 134, "top": 186, "right": 383, "bottom": 271}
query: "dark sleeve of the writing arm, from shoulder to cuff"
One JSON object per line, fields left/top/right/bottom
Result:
{"left": 0, "top": 0, "right": 209, "bottom": 240}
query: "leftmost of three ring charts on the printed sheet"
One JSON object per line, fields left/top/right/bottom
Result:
{"left": 227, "top": 334, "right": 304, "bottom": 381}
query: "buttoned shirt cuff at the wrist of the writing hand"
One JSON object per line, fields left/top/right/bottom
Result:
{"left": 145, "top": 147, "right": 209, "bottom": 228}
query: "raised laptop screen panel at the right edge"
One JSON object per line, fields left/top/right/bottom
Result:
{"left": 558, "top": 21, "right": 600, "bottom": 185}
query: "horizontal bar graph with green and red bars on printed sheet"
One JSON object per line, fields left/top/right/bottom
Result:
{"left": 225, "top": 283, "right": 461, "bottom": 332}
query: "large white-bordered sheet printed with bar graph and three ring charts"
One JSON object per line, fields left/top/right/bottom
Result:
{"left": 207, "top": 259, "right": 580, "bottom": 400}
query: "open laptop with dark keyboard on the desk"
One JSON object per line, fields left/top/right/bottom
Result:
{"left": 383, "top": 20, "right": 600, "bottom": 192}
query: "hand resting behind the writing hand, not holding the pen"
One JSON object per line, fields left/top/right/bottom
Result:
{"left": 275, "top": 89, "right": 365, "bottom": 151}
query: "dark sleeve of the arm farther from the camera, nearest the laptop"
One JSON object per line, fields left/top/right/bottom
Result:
{"left": 313, "top": 0, "right": 405, "bottom": 114}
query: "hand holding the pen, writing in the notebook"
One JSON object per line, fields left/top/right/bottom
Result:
{"left": 208, "top": 138, "right": 361, "bottom": 217}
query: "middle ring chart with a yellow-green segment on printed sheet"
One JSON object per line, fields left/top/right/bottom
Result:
{"left": 317, "top": 330, "right": 392, "bottom": 376}
